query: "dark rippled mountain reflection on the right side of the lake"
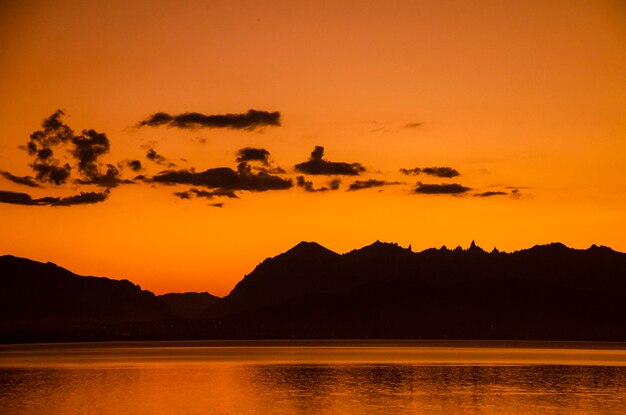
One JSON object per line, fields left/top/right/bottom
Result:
{"left": 244, "top": 365, "right": 626, "bottom": 414}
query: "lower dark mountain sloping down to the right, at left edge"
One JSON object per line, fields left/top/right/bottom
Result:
{"left": 0, "top": 255, "right": 173, "bottom": 327}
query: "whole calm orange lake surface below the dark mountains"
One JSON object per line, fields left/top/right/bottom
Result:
{"left": 0, "top": 342, "right": 626, "bottom": 415}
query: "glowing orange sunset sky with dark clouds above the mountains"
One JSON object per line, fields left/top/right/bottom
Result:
{"left": 0, "top": 0, "right": 626, "bottom": 296}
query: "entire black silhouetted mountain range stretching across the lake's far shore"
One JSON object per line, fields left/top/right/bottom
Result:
{"left": 0, "top": 241, "right": 626, "bottom": 342}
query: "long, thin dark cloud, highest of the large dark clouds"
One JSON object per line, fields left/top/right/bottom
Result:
{"left": 137, "top": 110, "right": 280, "bottom": 130}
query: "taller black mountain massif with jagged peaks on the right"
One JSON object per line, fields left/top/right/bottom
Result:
{"left": 204, "top": 241, "right": 626, "bottom": 340}
